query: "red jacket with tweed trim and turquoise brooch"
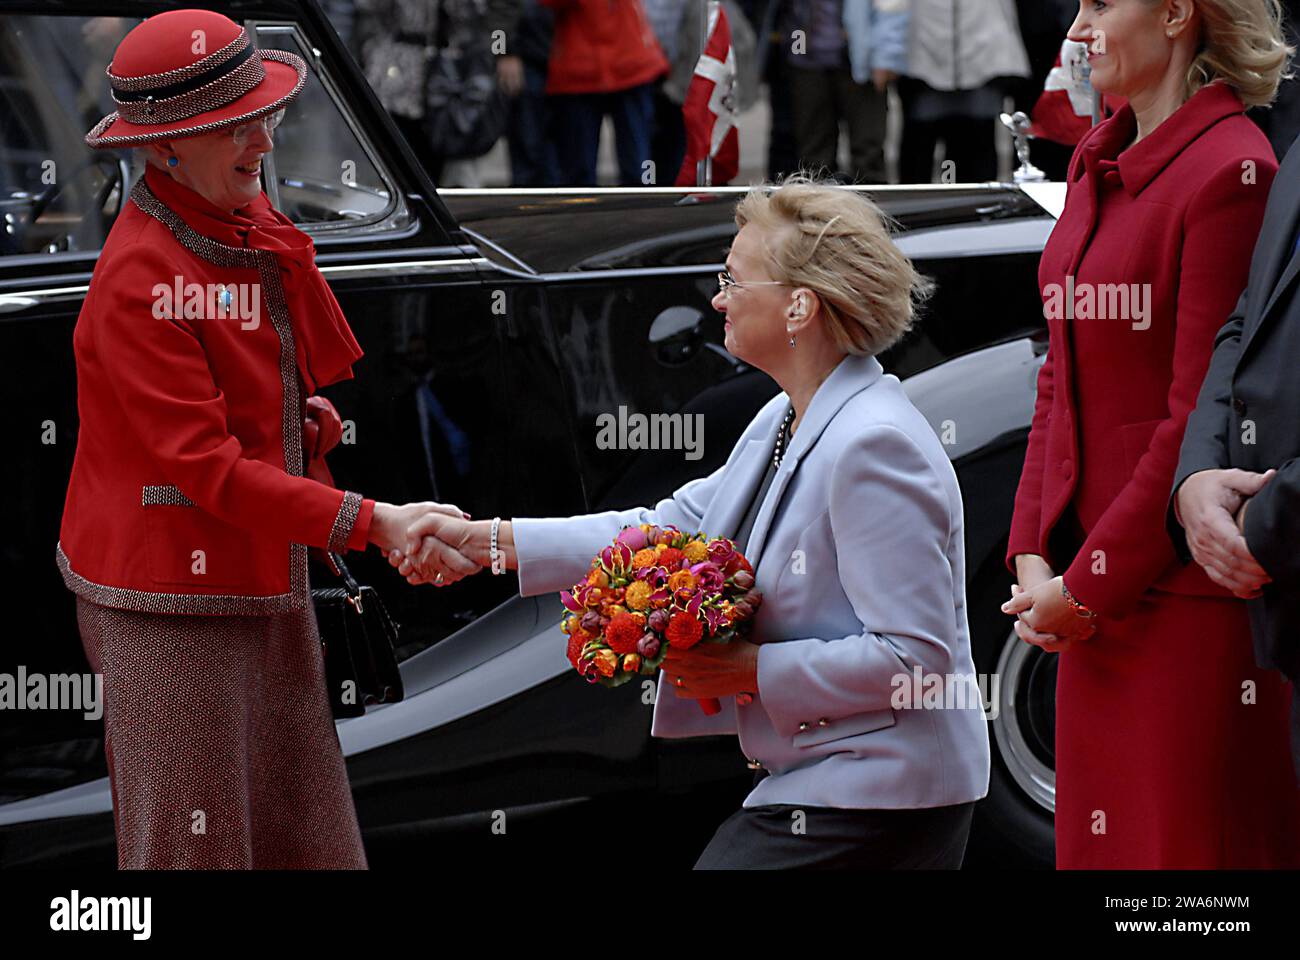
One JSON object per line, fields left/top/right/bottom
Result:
{"left": 57, "top": 170, "right": 374, "bottom": 615}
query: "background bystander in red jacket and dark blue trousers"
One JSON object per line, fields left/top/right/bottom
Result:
{"left": 542, "top": 0, "right": 677, "bottom": 186}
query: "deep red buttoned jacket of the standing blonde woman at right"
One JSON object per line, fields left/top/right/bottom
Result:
{"left": 1008, "top": 82, "right": 1278, "bottom": 617}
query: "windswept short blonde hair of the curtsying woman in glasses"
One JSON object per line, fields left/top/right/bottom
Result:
{"left": 736, "top": 172, "right": 933, "bottom": 355}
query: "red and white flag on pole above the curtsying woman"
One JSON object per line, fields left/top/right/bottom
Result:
{"left": 676, "top": 0, "right": 740, "bottom": 186}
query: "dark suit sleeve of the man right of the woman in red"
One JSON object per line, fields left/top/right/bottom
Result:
{"left": 1165, "top": 283, "right": 1247, "bottom": 562}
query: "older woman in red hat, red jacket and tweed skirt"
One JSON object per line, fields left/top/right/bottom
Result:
{"left": 57, "top": 10, "right": 473, "bottom": 868}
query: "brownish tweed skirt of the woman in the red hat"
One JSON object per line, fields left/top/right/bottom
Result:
{"left": 77, "top": 597, "right": 367, "bottom": 869}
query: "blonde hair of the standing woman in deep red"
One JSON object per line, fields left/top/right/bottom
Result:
{"left": 1175, "top": 0, "right": 1296, "bottom": 107}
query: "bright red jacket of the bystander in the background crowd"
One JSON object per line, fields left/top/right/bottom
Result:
{"left": 542, "top": 0, "right": 668, "bottom": 94}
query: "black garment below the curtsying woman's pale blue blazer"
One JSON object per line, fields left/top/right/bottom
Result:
{"left": 696, "top": 775, "right": 975, "bottom": 870}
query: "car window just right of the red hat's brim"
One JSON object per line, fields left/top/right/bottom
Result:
{"left": 256, "top": 23, "right": 407, "bottom": 233}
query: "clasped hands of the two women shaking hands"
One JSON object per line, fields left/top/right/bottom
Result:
{"left": 371, "top": 502, "right": 519, "bottom": 587}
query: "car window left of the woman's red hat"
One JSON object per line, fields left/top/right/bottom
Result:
{"left": 0, "top": 14, "right": 139, "bottom": 255}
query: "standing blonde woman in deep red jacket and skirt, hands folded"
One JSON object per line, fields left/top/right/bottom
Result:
{"left": 1002, "top": 0, "right": 1300, "bottom": 868}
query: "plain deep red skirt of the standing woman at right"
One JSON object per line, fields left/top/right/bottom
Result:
{"left": 1056, "top": 591, "right": 1300, "bottom": 869}
